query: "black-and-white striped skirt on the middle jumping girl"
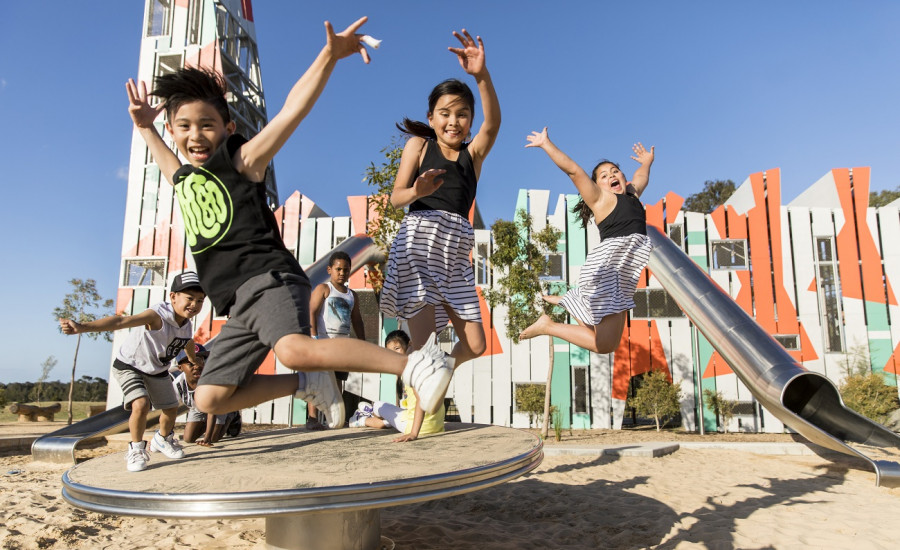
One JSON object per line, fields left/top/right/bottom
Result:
{"left": 380, "top": 210, "right": 481, "bottom": 332}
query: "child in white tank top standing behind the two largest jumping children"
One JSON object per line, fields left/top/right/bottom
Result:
{"left": 306, "top": 252, "right": 366, "bottom": 430}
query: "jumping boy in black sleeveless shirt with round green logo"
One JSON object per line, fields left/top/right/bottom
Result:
{"left": 126, "top": 17, "right": 452, "bottom": 428}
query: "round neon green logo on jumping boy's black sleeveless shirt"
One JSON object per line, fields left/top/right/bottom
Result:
{"left": 175, "top": 168, "right": 233, "bottom": 254}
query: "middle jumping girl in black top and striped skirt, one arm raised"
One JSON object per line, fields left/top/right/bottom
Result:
{"left": 380, "top": 25, "right": 500, "bottom": 392}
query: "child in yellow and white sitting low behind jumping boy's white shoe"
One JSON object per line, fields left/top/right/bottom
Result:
{"left": 350, "top": 330, "right": 445, "bottom": 442}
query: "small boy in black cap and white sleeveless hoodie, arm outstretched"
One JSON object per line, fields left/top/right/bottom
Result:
{"left": 59, "top": 271, "right": 206, "bottom": 472}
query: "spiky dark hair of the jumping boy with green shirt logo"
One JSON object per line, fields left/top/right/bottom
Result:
{"left": 150, "top": 67, "right": 231, "bottom": 124}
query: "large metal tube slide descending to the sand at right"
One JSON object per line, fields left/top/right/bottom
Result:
{"left": 647, "top": 226, "right": 900, "bottom": 487}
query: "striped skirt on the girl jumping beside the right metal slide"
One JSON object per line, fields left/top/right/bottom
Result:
{"left": 559, "top": 233, "right": 652, "bottom": 325}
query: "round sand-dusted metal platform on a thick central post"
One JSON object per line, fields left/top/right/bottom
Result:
{"left": 62, "top": 423, "right": 543, "bottom": 549}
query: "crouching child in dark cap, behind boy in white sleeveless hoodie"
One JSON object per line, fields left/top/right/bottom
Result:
{"left": 172, "top": 344, "right": 240, "bottom": 447}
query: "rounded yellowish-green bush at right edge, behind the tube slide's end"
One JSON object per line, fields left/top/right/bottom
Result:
{"left": 838, "top": 345, "right": 900, "bottom": 422}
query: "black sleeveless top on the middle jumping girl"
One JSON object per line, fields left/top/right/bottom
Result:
{"left": 409, "top": 139, "right": 478, "bottom": 219}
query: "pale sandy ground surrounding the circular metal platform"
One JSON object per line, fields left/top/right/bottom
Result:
{"left": 0, "top": 427, "right": 900, "bottom": 550}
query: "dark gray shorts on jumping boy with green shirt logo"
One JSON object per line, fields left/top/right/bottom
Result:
{"left": 197, "top": 272, "right": 310, "bottom": 386}
